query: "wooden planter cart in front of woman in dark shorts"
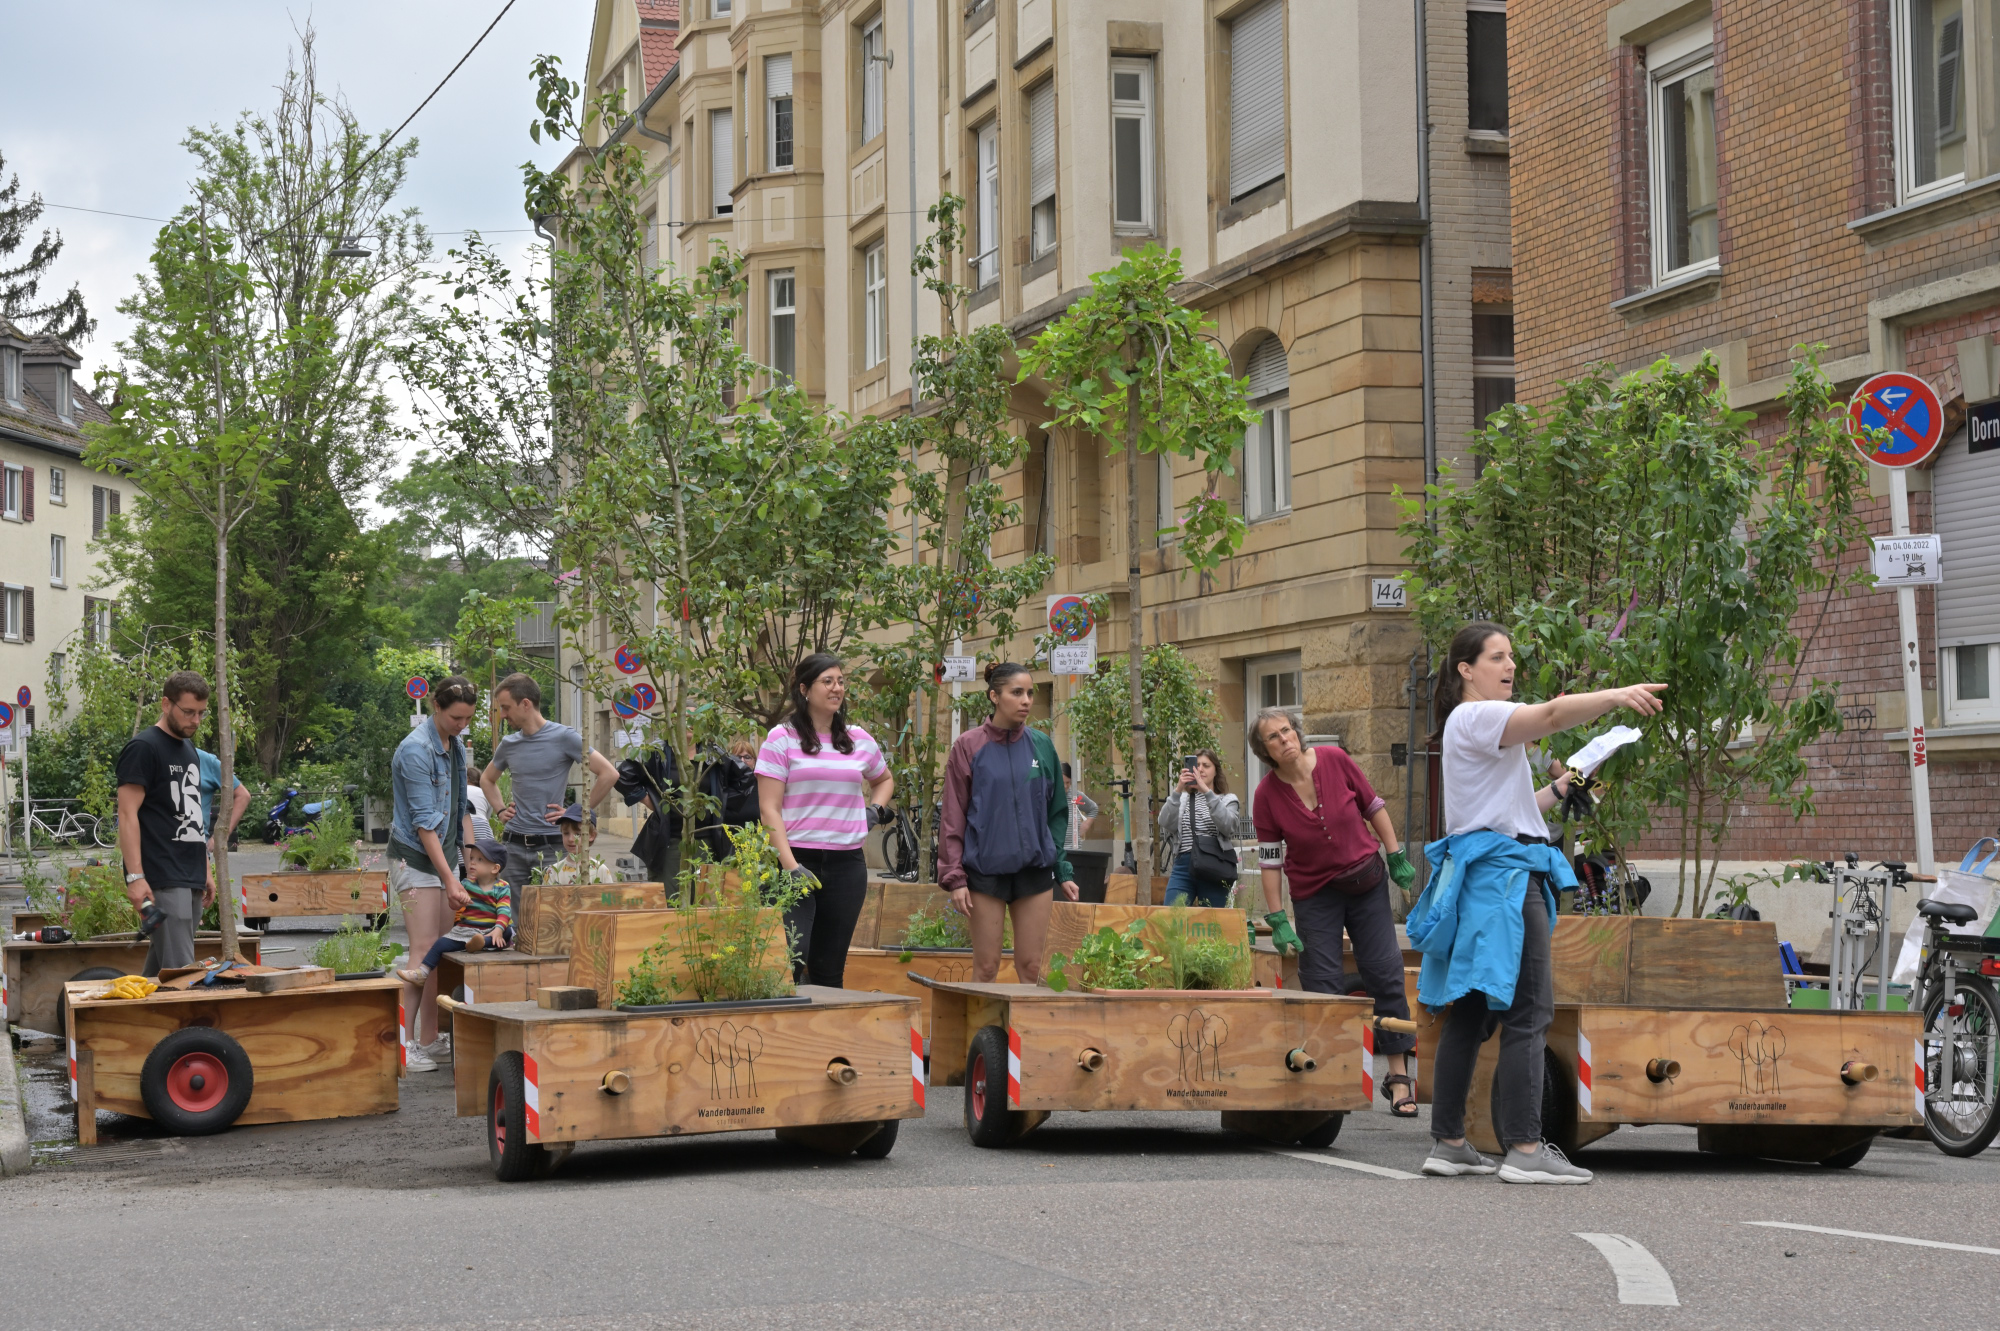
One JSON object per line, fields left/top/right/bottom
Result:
{"left": 912, "top": 971, "right": 1372, "bottom": 1147}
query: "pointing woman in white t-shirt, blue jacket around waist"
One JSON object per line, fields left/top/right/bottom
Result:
{"left": 1408, "top": 624, "right": 1666, "bottom": 1183}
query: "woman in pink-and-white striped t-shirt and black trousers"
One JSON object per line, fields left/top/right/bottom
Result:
{"left": 756, "top": 652, "right": 896, "bottom": 989}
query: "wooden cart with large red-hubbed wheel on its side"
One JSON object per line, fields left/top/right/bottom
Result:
{"left": 66, "top": 967, "right": 402, "bottom": 1145}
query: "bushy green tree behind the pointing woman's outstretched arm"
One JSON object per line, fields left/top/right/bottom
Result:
{"left": 1402, "top": 348, "right": 1868, "bottom": 915}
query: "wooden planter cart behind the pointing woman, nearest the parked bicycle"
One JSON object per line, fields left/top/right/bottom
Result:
{"left": 1406, "top": 915, "right": 1924, "bottom": 1167}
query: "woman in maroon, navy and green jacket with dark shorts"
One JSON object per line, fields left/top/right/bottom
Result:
{"left": 938, "top": 662, "right": 1078, "bottom": 985}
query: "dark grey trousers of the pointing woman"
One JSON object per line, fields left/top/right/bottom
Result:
{"left": 1430, "top": 873, "right": 1556, "bottom": 1149}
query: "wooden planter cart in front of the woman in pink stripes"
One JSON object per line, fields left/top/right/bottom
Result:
{"left": 440, "top": 895, "right": 922, "bottom": 1181}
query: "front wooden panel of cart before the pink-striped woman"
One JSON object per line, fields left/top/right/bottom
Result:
{"left": 476, "top": 987, "right": 922, "bottom": 1143}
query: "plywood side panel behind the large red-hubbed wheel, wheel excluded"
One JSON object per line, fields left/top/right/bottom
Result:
{"left": 70, "top": 977, "right": 402, "bottom": 1123}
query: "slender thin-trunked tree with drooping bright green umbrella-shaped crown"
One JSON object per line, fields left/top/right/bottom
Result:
{"left": 1020, "top": 244, "right": 1254, "bottom": 899}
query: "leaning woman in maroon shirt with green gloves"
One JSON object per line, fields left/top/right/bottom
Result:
{"left": 1250, "top": 707, "right": 1416, "bottom": 1119}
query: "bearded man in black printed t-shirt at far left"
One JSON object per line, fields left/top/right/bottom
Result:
{"left": 118, "top": 669, "right": 216, "bottom": 975}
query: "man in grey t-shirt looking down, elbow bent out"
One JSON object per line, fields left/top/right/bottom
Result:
{"left": 480, "top": 673, "right": 618, "bottom": 895}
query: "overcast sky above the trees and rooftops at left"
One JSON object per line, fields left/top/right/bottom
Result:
{"left": 0, "top": 0, "right": 594, "bottom": 497}
